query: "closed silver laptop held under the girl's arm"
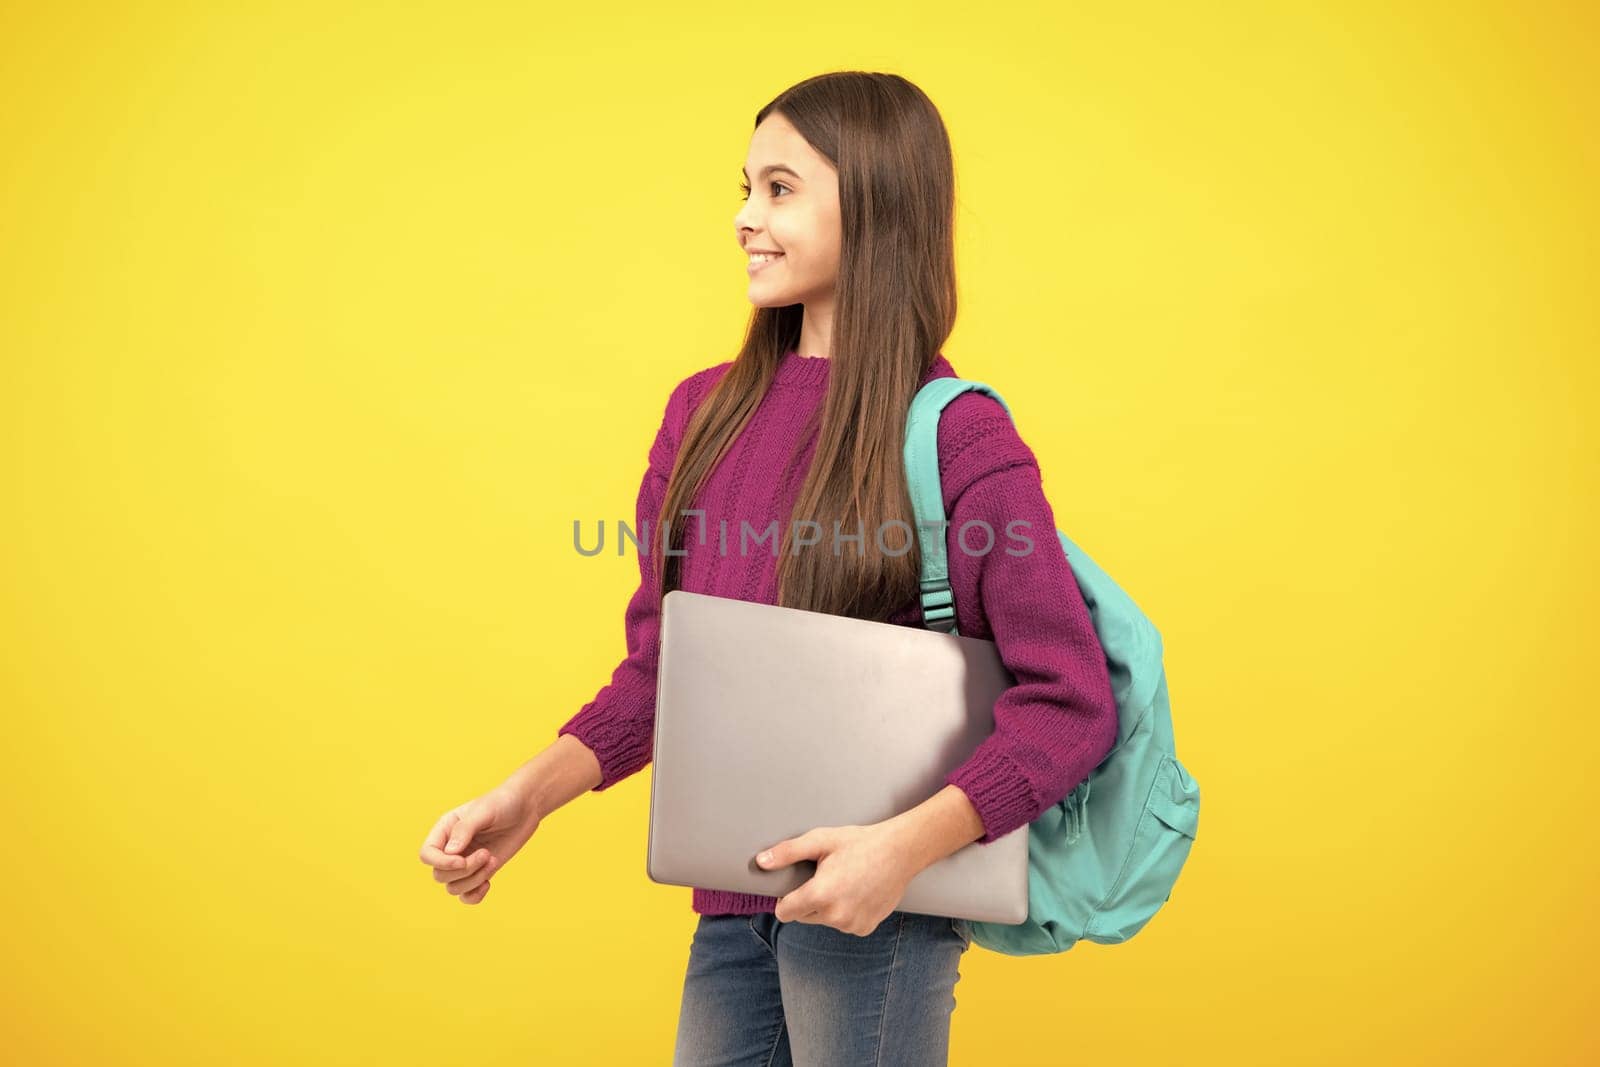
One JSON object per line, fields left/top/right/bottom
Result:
{"left": 646, "top": 589, "right": 1027, "bottom": 923}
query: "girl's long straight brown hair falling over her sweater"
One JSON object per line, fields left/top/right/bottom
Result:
{"left": 656, "top": 70, "right": 955, "bottom": 621}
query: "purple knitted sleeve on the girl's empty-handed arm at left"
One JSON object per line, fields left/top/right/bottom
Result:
{"left": 555, "top": 374, "right": 699, "bottom": 792}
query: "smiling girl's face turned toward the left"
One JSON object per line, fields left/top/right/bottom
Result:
{"left": 733, "top": 112, "right": 840, "bottom": 307}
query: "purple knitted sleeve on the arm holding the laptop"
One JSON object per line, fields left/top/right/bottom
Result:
{"left": 939, "top": 394, "right": 1117, "bottom": 845}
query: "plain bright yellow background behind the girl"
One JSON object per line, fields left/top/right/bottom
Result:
{"left": 0, "top": 3, "right": 1600, "bottom": 1067}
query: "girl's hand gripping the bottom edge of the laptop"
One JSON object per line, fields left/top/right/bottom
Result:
{"left": 755, "top": 822, "right": 917, "bottom": 937}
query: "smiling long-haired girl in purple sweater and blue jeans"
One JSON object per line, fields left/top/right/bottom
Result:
{"left": 422, "top": 72, "right": 1117, "bottom": 1065}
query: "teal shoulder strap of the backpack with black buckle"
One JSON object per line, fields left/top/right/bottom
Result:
{"left": 906, "top": 378, "right": 1011, "bottom": 633}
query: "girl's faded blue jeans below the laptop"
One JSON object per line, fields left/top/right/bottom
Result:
{"left": 672, "top": 912, "right": 973, "bottom": 1067}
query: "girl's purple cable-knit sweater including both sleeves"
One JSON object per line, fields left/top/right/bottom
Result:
{"left": 557, "top": 352, "right": 1117, "bottom": 915}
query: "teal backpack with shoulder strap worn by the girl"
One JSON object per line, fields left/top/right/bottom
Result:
{"left": 906, "top": 378, "right": 1200, "bottom": 957}
